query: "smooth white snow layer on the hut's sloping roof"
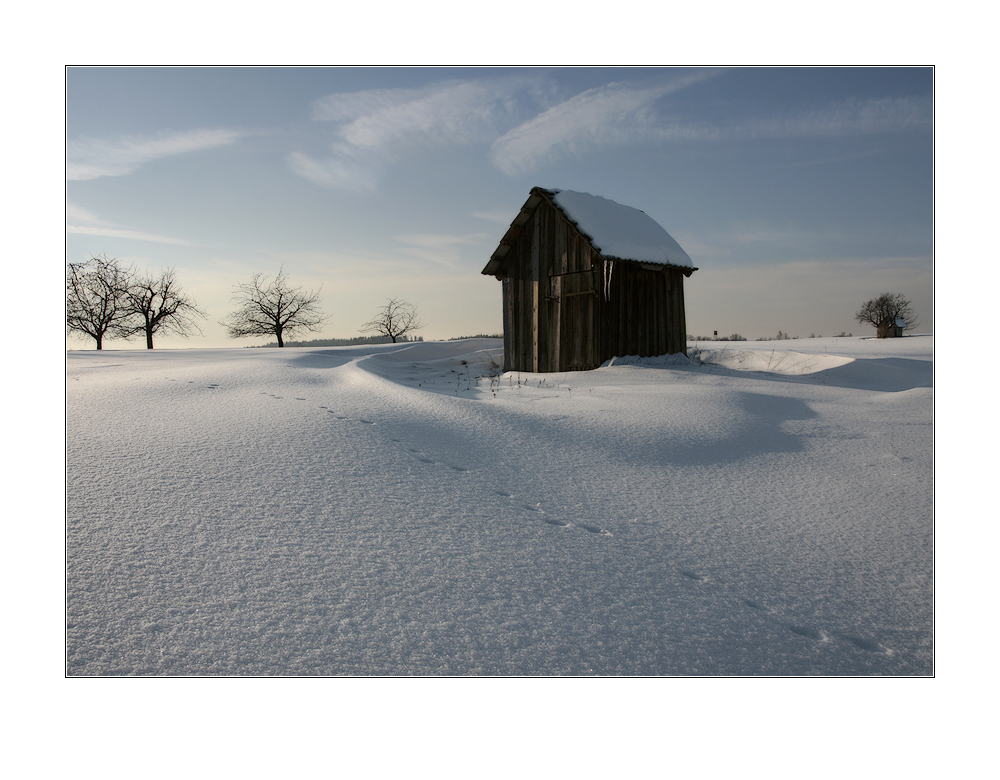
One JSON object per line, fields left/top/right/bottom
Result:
{"left": 548, "top": 189, "right": 694, "bottom": 268}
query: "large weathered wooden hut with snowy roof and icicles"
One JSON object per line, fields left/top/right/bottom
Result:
{"left": 483, "top": 187, "right": 698, "bottom": 372}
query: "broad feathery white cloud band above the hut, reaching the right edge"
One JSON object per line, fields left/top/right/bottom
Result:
{"left": 287, "top": 69, "right": 932, "bottom": 191}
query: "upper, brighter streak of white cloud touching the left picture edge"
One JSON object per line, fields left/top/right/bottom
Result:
{"left": 66, "top": 129, "right": 244, "bottom": 181}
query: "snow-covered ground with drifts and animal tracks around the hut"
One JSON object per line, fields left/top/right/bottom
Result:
{"left": 67, "top": 336, "right": 933, "bottom": 675}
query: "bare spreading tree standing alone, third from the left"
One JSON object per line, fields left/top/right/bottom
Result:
{"left": 219, "top": 268, "right": 330, "bottom": 347}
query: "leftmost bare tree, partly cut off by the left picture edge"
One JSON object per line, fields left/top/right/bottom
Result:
{"left": 66, "top": 255, "right": 131, "bottom": 349}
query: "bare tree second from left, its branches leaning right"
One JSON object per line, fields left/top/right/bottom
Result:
{"left": 124, "top": 268, "right": 207, "bottom": 349}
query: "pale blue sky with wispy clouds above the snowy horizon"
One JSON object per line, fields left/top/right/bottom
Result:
{"left": 66, "top": 67, "right": 934, "bottom": 348}
